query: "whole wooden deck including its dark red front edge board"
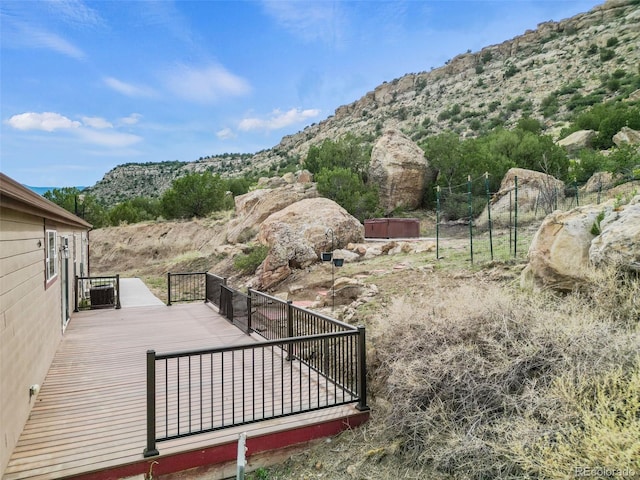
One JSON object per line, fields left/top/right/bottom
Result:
{"left": 3, "top": 304, "right": 366, "bottom": 480}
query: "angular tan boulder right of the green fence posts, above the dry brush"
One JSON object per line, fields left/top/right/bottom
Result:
{"left": 522, "top": 205, "right": 603, "bottom": 291}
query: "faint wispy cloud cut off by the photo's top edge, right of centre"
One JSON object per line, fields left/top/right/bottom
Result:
{"left": 263, "top": 0, "right": 347, "bottom": 44}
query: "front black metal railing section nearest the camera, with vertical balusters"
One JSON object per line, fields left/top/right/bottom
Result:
{"left": 144, "top": 327, "right": 368, "bottom": 457}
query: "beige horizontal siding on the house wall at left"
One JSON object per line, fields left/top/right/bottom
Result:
{"left": 0, "top": 209, "right": 87, "bottom": 475}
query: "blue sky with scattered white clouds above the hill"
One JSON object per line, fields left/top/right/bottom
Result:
{"left": 0, "top": 0, "right": 602, "bottom": 186}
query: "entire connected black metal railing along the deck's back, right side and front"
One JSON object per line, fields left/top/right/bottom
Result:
{"left": 144, "top": 273, "right": 369, "bottom": 457}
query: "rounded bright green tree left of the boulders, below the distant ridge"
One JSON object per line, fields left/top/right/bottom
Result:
{"left": 160, "top": 172, "right": 227, "bottom": 218}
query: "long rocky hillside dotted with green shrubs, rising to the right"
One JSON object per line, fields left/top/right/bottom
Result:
{"left": 91, "top": 0, "right": 640, "bottom": 204}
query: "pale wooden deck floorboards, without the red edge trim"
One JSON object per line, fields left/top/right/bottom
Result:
{"left": 3, "top": 304, "right": 362, "bottom": 480}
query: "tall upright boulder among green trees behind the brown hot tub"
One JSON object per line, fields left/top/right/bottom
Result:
{"left": 369, "top": 129, "right": 430, "bottom": 214}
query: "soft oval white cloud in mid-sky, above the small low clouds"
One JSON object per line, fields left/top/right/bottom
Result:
{"left": 166, "top": 65, "right": 251, "bottom": 103}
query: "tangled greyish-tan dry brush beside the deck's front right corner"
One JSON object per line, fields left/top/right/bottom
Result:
{"left": 364, "top": 268, "right": 640, "bottom": 479}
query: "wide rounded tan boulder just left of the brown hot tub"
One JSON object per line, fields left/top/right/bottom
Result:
{"left": 256, "top": 198, "right": 364, "bottom": 289}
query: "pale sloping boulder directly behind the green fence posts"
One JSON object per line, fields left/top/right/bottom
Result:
{"left": 475, "top": 168, "right": 564, "bottom": 226}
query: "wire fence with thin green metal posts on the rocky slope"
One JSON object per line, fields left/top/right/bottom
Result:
{"left": 427, "top": 172, "right": 640, "bottom": 264}
